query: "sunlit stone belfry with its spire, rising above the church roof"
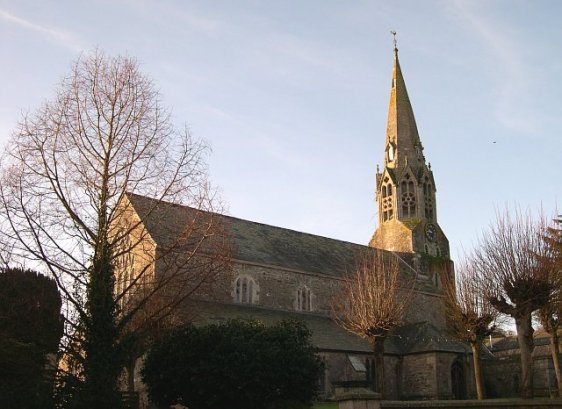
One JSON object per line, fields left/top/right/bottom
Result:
{"left": 369, "top": 43, "right": 449, "bottom": 259}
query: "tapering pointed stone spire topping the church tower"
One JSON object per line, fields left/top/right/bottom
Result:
{"left": 384, "top": 35, "right": 425, "bottom": 168}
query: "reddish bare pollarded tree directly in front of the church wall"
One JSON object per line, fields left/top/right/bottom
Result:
{"left": 332, "top": 250, "right": 412, "bottom": 395}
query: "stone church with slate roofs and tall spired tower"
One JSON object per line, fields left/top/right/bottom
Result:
{"left": 120, "top": 48, "right": 474, "bottom": 400}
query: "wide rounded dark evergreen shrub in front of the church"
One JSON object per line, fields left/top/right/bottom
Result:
{"left": 142, "top": 320, "right": 322, "bottom": 409}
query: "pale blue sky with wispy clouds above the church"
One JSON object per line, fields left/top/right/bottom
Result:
{"left": 0, "top": 0, "right": 562, "bottom": 260}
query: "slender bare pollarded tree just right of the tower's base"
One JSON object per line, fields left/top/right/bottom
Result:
{"left": 443, "top": 260, "right": 498, "bottom": 399}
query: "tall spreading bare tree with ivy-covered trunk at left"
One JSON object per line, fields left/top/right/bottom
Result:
{"left": 0, "top": 51, "right": 229, "bottom": 409}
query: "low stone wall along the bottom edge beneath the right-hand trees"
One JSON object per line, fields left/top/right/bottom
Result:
{"left": 380, "top": 399, "right": 562, "bottom": 409}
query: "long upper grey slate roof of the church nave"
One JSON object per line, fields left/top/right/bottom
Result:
{"left": 128, "top": 194, "right": 370, "bottom": 276}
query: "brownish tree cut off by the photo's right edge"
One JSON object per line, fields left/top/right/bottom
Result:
{"left": 537, "top": 216, "right": 562, "bottom": 395}
